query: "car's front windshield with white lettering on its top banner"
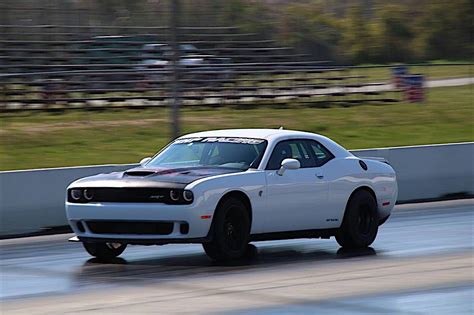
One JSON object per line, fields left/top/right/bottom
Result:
{"left": 146, "top": 137, "right": 267, "bottom": 170}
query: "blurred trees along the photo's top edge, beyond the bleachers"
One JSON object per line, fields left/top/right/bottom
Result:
{"left": 11, "top": 0, "right": 474, "bottom": 64}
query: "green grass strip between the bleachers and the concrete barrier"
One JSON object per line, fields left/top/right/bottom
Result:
{"left": 0, "top": 85, "right": 474, "bottom": 170}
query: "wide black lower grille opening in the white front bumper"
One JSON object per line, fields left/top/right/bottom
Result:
{"left": 86, "top": 221, "right": 173, "bottom": 235}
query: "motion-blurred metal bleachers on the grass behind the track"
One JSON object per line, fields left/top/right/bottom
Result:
{"left": 0, "top": 25, "right": 404, "bottom": 115}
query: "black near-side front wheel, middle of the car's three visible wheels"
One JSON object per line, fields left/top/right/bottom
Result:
{"left": 202, "top": 198, "right": 250, "bottom": 261}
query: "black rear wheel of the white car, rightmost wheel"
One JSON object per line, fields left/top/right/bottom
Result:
{"left": 336, "top": 190, "right": 378, "bottom": 248}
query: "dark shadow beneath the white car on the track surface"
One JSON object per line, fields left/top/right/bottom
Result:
{"left": 75, "top": 245, "right": 377, "bottom": 285}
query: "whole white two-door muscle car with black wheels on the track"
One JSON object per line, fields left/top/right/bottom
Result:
{"left": 66, "top": 129, "right": 398, "bottom": 260}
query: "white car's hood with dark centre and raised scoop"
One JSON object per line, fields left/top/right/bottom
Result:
{"left": 71, "top": 167, "right": 242, "bottom": 188}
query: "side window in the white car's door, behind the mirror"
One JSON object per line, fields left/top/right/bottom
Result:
{"left": 266, "top": 140, "right": 316, "bottom": 170}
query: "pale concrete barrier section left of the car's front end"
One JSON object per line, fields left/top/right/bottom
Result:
{"left": 0, "top": 165, "right": 137, "bottom": 236}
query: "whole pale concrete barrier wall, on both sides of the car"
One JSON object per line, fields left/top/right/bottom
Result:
{"left": 0, "top": 142, "right": 474, "bottom": 236}
